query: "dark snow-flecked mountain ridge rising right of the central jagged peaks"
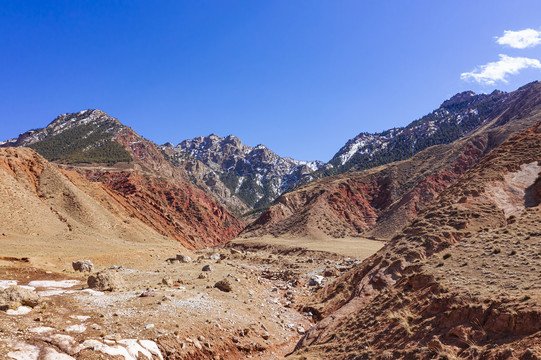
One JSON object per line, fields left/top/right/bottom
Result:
{"left": 297, "top": 90, "right": 509, "bottom": 185}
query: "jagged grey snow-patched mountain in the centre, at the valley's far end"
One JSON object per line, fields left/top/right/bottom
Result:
{"left": 162, "top": 134, "right": 325, "bottom": 209}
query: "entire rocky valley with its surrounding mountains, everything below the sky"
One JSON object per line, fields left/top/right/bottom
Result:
{"left": 0, "top": 82, "right": 541, "bottom": 360}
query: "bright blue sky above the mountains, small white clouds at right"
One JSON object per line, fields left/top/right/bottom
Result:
{"left": 0, "top": 0, "right": 541, "bottom": 161}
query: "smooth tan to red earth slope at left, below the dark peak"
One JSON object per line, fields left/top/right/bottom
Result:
{"left": 0, "top": 148, "right": 242, "bottom": 256}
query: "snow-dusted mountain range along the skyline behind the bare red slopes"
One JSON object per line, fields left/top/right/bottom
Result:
{"left": 4, "top": 83, "right": 536, "bottom": 219}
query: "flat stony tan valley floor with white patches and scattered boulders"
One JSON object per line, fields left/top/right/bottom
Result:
{"left": 0, "top": 235, "right": 382, "bottom": 360}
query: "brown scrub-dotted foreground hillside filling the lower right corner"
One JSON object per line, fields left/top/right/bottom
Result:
{"left": 297, "top": 122, "right": 541, "bottom": 359}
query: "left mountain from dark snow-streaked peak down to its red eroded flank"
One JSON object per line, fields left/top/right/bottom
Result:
{"left": 1, "top": 110, "right": 243, "bottom": 248}
